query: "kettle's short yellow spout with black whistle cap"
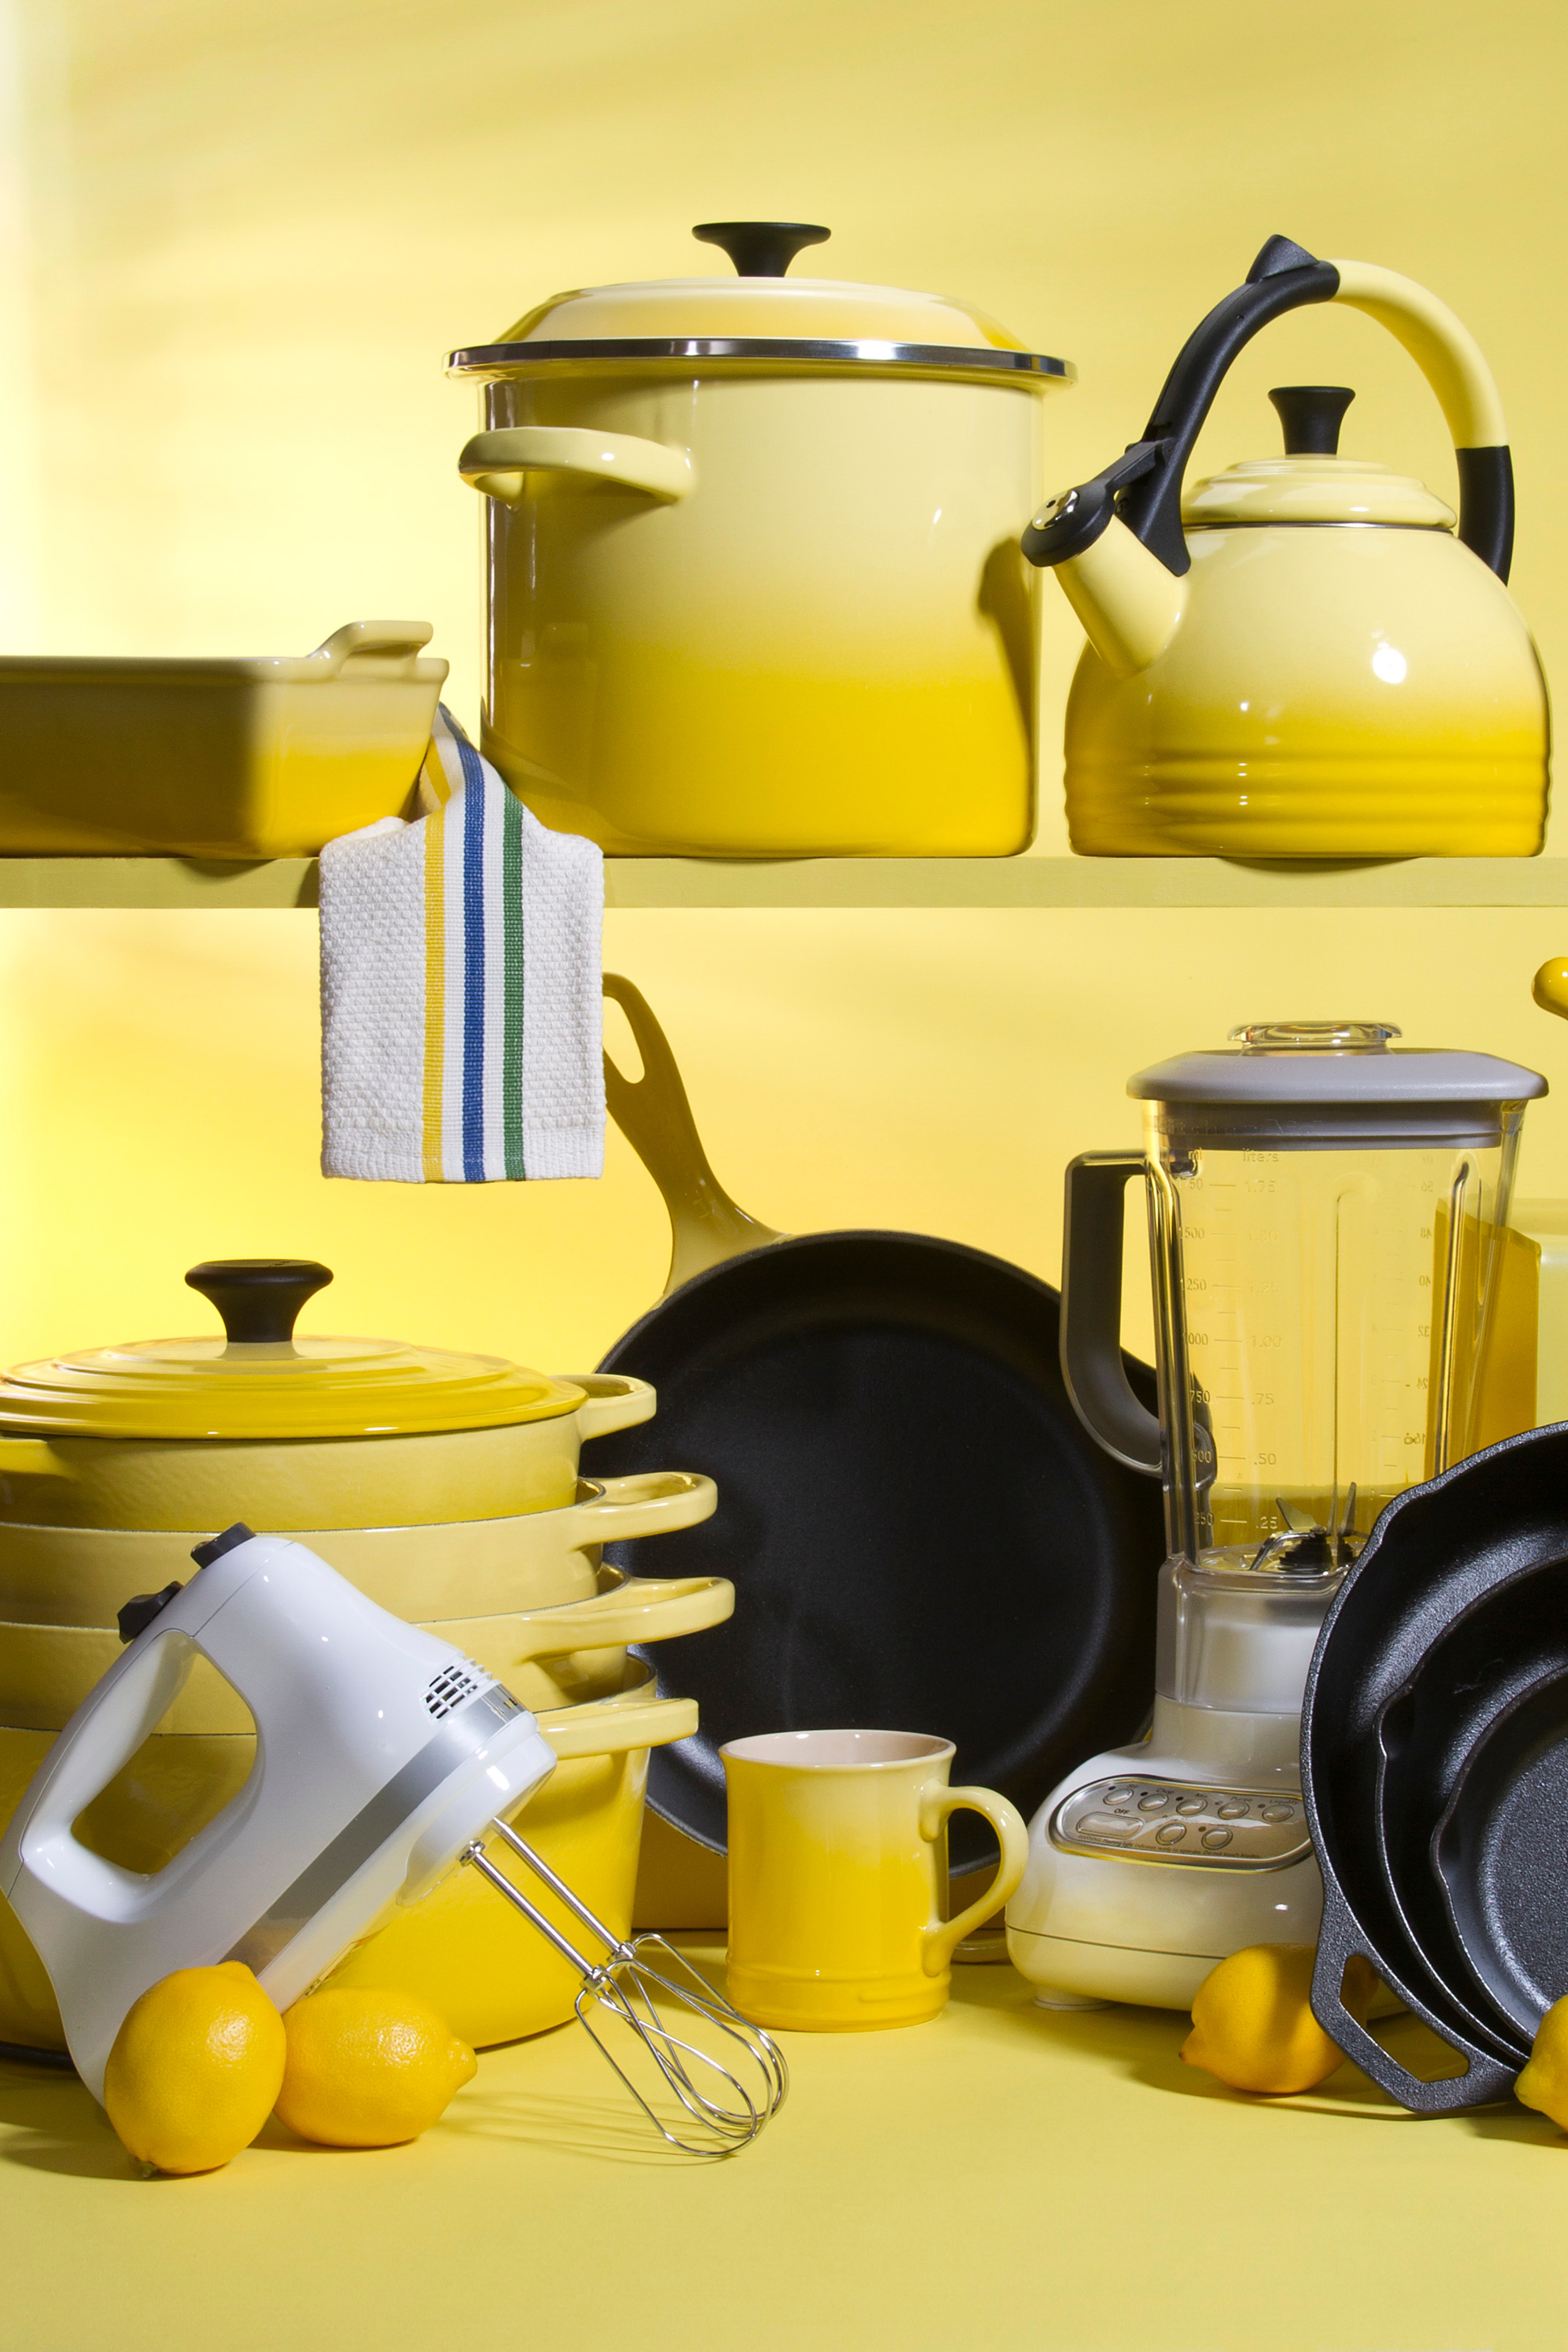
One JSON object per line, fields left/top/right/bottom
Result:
{"left": 1023, "top": 442, "right": 1189, "bottom": 678}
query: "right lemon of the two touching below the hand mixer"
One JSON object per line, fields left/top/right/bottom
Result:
{"left": 277, "top": 1985, "right": 479, "bottom": 2147}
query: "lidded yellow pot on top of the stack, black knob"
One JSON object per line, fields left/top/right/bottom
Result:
{"left": 0, "top": 1258, "right": 654, "bottom": 1552}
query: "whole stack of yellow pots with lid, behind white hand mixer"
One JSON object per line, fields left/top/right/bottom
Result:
{"left": 0, "top": 1258, "right": 734, "bottom": 2049}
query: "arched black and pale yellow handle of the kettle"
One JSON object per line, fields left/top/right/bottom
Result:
{"left": 1023, "top": 237, "right": 1514, "bottom": 581}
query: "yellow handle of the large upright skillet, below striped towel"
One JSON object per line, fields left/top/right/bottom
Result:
{"left": 604, "top": 971, "right": 783, "bottom": 1298}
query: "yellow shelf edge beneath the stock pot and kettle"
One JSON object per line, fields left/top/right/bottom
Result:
{"left": 0, "top": 856, "right": 1568, "bottom": 908}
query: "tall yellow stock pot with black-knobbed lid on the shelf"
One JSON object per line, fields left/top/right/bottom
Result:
{"left": 449, "top": 221, "right": 1075, "bottom": 856}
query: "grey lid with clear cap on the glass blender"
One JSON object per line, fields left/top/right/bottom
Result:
{"left": 1126, "top": 1021, "right": 1547, "bottom": 1106}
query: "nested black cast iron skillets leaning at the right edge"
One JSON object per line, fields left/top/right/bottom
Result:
{"left": 1302, "top": 1425, "right": 1568, "bottom": 2115}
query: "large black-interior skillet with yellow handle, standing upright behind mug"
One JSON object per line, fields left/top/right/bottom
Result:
{"left": 592, "top": 976, "right": 1164, "bottom": 1872}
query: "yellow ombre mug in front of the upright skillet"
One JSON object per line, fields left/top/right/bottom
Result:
{"left": 719, "top": 1731, "right": 1030, "bottom": 2032}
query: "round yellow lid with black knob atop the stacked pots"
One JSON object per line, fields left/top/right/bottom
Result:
{"left": 0, "top": 1258, "right": 583, "bottom": 1442}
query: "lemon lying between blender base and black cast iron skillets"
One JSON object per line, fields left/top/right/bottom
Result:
{"left": 1182, "top": 1943, "right": 1378, "bottom": 2096}
